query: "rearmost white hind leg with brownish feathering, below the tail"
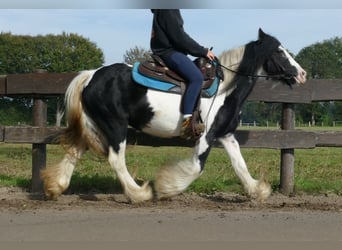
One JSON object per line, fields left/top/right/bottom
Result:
{"left": 40, "top": 147, "right": 84, "bottom": 200}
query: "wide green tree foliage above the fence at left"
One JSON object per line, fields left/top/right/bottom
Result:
{"left": 0, "top": 32, "right": 104, "bottom": 74}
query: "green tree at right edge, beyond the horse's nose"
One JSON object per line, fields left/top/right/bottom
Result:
{"left": 296, "top": 37, "right": 342, "bottom": 125}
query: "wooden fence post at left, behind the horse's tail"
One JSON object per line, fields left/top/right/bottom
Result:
{"left": 31, "top": 71, "right": 47, "bottom": 193}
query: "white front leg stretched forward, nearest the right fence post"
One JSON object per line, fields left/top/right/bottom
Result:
{"left": 219, "top": 134, "right": 272, "bottom": 201}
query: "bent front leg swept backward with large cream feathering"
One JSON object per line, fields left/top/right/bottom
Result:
{"left": 155, "top": 136, "right": 210, "bottom": 199}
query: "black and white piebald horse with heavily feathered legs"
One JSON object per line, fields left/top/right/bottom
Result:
{"left": 41, "top": 29, "right": 306, "bottom": 203}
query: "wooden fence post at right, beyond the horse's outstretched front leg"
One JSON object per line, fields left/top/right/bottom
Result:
{"left": 280, "top": 103, "right": 295, "bottom": 195}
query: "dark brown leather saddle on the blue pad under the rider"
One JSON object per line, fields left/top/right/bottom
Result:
{"left": 138, "top": 54, "right": 223, "bottom": 94}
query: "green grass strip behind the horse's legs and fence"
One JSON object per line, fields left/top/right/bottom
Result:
{"left": 0, "top": 141, "right": 342, "bottom": 195}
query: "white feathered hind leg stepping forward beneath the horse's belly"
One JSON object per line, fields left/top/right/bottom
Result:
{"left": 108, "top": 141, "right": 153, "bottom": 203}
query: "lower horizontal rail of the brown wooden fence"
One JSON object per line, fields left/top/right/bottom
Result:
{"left": 0, "top": 126, "right": 342, "bottom": 149}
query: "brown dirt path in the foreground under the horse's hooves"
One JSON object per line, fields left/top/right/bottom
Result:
{"left": 0, "top": 188, "right": 342, "bottom": 242}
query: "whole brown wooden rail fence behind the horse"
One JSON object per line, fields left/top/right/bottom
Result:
{"left": 0, "top": 73, "right": 342, "bottom": 194}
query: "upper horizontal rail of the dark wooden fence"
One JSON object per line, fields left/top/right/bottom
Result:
{"left": 0, "top": 73, "right": 342, "bottom": 103}
